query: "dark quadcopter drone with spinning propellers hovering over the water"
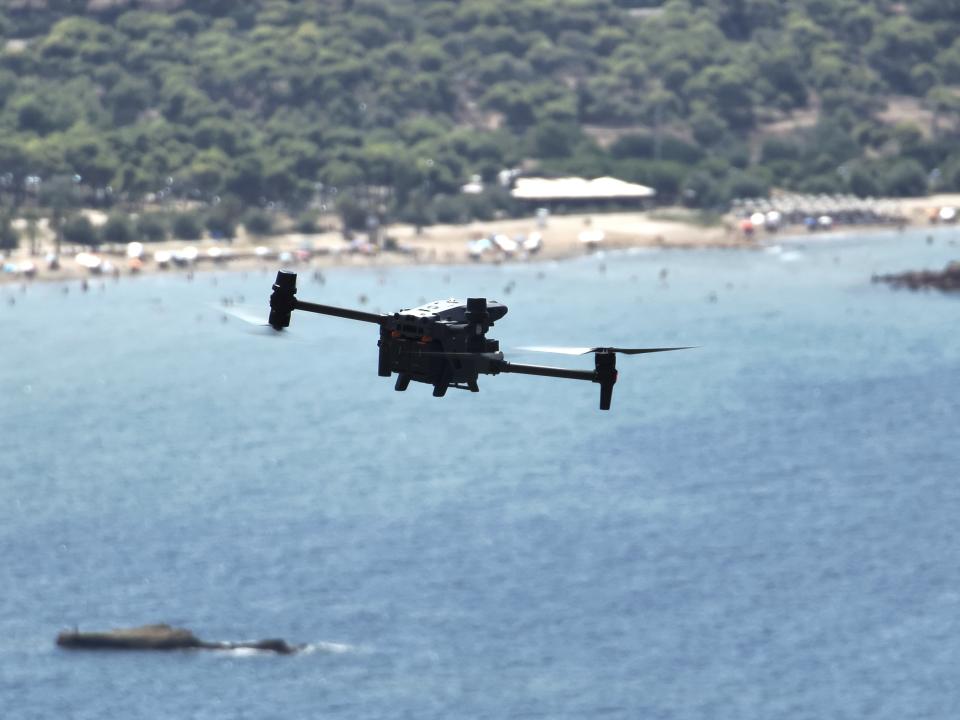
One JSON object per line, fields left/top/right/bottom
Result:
{"left": 268, "top": 270, "right": 690, "bottom": 410}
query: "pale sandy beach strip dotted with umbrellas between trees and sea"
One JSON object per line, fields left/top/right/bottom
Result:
{"left": 0, "top": 194, "right": 960, "bottom": 283}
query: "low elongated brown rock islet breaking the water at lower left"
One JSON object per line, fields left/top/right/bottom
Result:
{"left": 57, "top": 625, "right": 303, "bottom": 655}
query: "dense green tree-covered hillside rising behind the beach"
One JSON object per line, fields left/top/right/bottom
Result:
{"left": 0, "top": 0, "right": 960, "bottom": 233}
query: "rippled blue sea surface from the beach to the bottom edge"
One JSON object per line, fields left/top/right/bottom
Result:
{"left": 0, "top": 229, "right": 960, "bottom": 720}
